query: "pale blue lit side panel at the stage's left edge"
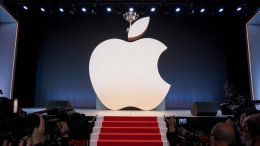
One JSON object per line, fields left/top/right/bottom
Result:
{"left": 0, "top": 5, "right": 18, "bottom": 99}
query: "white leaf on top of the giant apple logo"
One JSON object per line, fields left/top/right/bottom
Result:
{"left": 128, "top": 17, "right": 150, "bottom": 41}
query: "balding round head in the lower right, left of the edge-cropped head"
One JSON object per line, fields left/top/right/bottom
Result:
{"left": 210, "top": 122, "right": 235, "bottom": 146}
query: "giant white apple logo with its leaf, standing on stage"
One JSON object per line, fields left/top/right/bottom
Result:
{"left": 89, "top": 17, "right": 170, "bottom": 110}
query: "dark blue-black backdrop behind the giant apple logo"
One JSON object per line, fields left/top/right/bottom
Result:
{"left": 14, "top": 14, "right": 249, "bottom": 109}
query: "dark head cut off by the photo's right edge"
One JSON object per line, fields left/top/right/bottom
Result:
{"left": 241, "top": 113, "right": 260, "bottom": 145}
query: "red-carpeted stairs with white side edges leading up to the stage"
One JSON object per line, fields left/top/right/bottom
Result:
{"left": 90, "top": 116, "right": 169, "bottom": 146}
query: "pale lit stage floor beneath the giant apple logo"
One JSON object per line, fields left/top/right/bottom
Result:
{"left": 23, "top": 108, "right": 227, "bottom": 117}
